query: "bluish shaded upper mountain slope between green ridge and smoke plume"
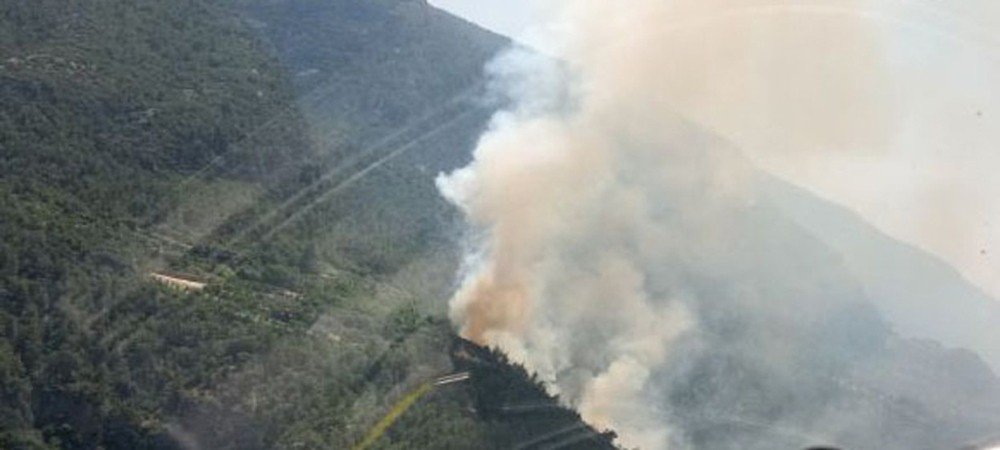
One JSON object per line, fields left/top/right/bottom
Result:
{"left": 225, "top": 0, "right": 507, "bottom": 302}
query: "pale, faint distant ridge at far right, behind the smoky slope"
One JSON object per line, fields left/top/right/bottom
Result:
{"left": 764, "top": 179, "right": 1000, "bottom": 371}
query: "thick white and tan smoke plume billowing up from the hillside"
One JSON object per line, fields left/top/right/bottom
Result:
{"left": 438, "top": 0, "right": 988, "bottom": 450}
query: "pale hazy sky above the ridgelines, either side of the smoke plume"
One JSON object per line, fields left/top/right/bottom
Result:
{"left": 437, "top": 0, "right": 1000, "bottom": 306}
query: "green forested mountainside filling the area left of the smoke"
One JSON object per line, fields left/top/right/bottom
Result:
{"left": 0, "top": 0, "right": 608, "bottom": 449}
